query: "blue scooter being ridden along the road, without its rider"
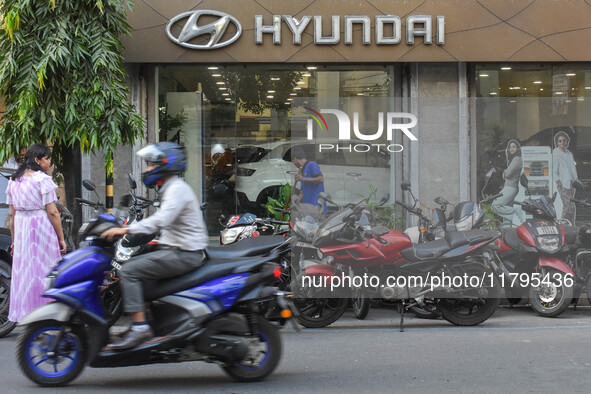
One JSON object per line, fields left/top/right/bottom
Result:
{"left": 16, "top": 214, "right": 291, "bottom": 386}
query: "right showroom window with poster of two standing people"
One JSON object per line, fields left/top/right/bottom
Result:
{"left": 471, "top": 64, "right": 591, "bottom": 222}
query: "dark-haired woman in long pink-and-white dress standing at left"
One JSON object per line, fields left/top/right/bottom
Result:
{"left": 6, "top": 144, "right": 66, "bottom": 322}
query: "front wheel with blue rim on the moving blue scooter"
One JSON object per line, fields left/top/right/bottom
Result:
{"left": 16, "top": 320, "right": 86, "bottom": 387}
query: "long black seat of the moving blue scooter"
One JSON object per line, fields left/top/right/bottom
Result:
{"left": 143, "top": 256, "right": 268, "bottom": 301}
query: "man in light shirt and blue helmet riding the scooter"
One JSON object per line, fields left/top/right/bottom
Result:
{"left": 101, "top": 142, "right": 207, "bottom": 350}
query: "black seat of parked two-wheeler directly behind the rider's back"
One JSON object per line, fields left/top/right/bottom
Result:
{"left": 205, "top": 235, "right": 285, "bottom": 260}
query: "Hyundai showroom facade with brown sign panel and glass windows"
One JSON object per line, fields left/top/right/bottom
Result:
{"left": 83, "top": 0, "right": 591, "bottom": 235}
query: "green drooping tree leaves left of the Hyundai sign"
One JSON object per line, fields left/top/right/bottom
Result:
{"left": 0, "top": 0, "right": 143, "bottom": 169}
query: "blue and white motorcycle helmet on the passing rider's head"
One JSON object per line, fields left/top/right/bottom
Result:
{"left": 137, "top": 142, "right": 187, "bottom": 187}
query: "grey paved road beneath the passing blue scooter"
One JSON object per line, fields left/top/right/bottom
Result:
{"left": 0, "top": 306, "right": 591, "bottom": 393}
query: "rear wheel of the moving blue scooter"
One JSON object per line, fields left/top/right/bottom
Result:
{"left": 222, "top": 319, "right": 282, "bottom": 382}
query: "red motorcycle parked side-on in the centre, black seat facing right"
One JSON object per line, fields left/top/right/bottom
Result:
{"left": 291, "top": 193, "right": 500, "bottom": 326}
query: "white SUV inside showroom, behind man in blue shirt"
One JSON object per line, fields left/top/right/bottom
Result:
{"left": 235, "top": 141, "right": 390, "bottom": 212}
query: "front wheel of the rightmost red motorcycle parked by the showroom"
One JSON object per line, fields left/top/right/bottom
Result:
{"left": 529, "top": 269, "right": 573, "bottom": 317}
